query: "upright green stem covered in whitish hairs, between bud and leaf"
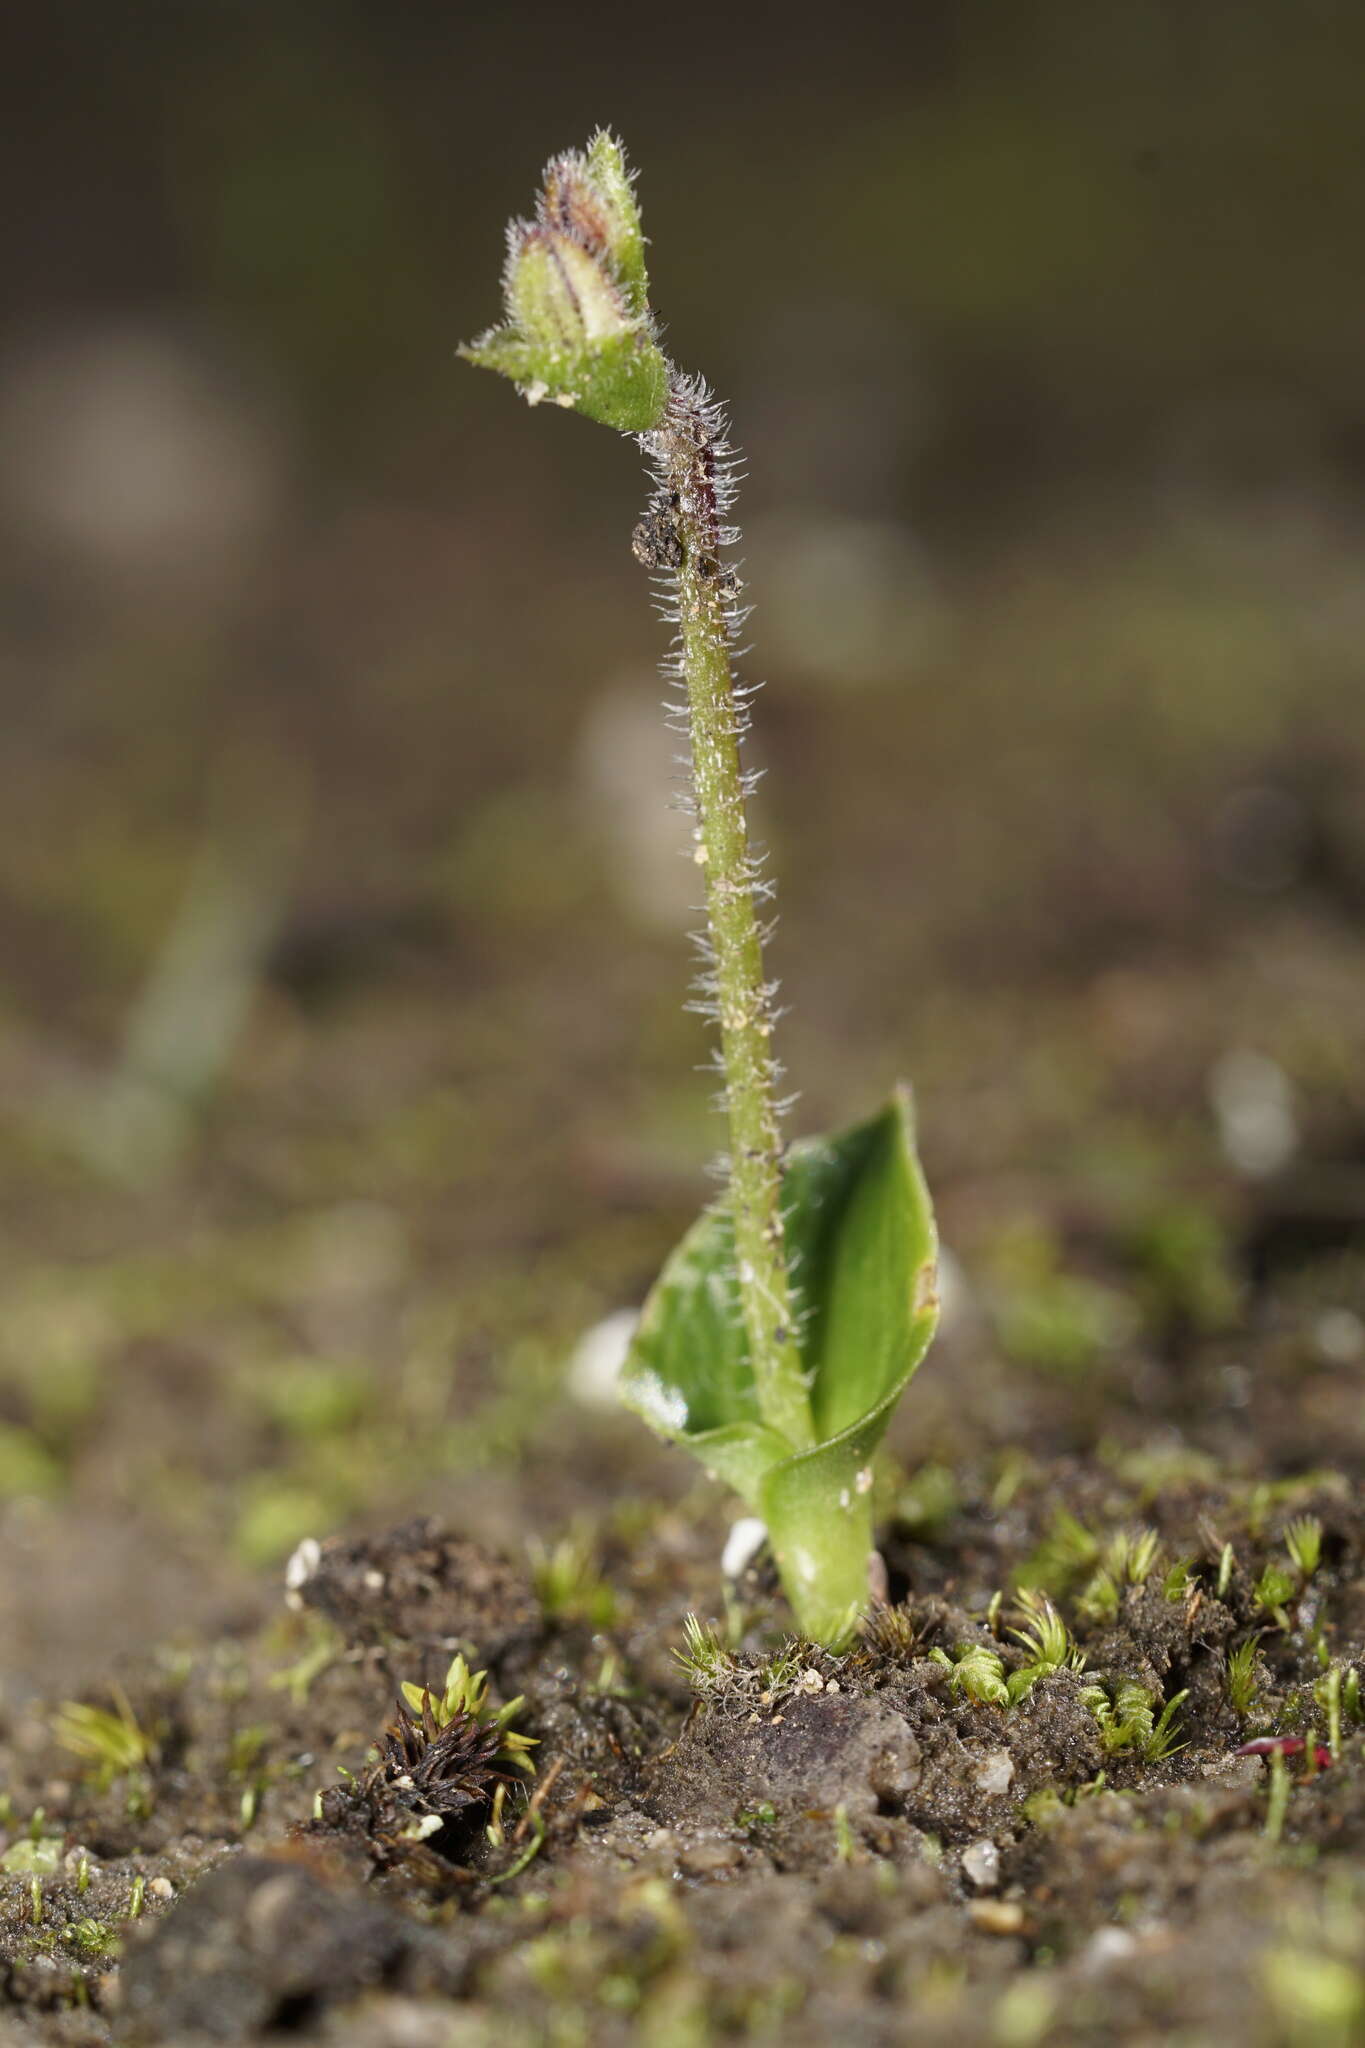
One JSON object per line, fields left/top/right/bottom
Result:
{"left": 636, "top": 375, "right": 814, "bottom": 1450}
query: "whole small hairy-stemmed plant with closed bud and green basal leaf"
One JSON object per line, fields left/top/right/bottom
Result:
{"left": 463, "top": 133, "right": 937, "bottom": 1647}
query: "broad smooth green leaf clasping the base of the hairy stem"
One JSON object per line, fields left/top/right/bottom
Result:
{"left": 620, "top": 1090, "right": 937, "bottom": 1645}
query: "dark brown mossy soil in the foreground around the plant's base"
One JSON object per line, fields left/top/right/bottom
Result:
{"left": 4, "top": 1425, "right": 1365, "bottom": 2044}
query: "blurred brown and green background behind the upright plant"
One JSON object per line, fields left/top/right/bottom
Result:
{"left": 0, "top": 0, "right": 1365, "bottom": 1688}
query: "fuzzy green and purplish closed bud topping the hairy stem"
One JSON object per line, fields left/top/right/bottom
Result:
{"left": 460, "top": 131, "right": 669, "bottom": 434}
